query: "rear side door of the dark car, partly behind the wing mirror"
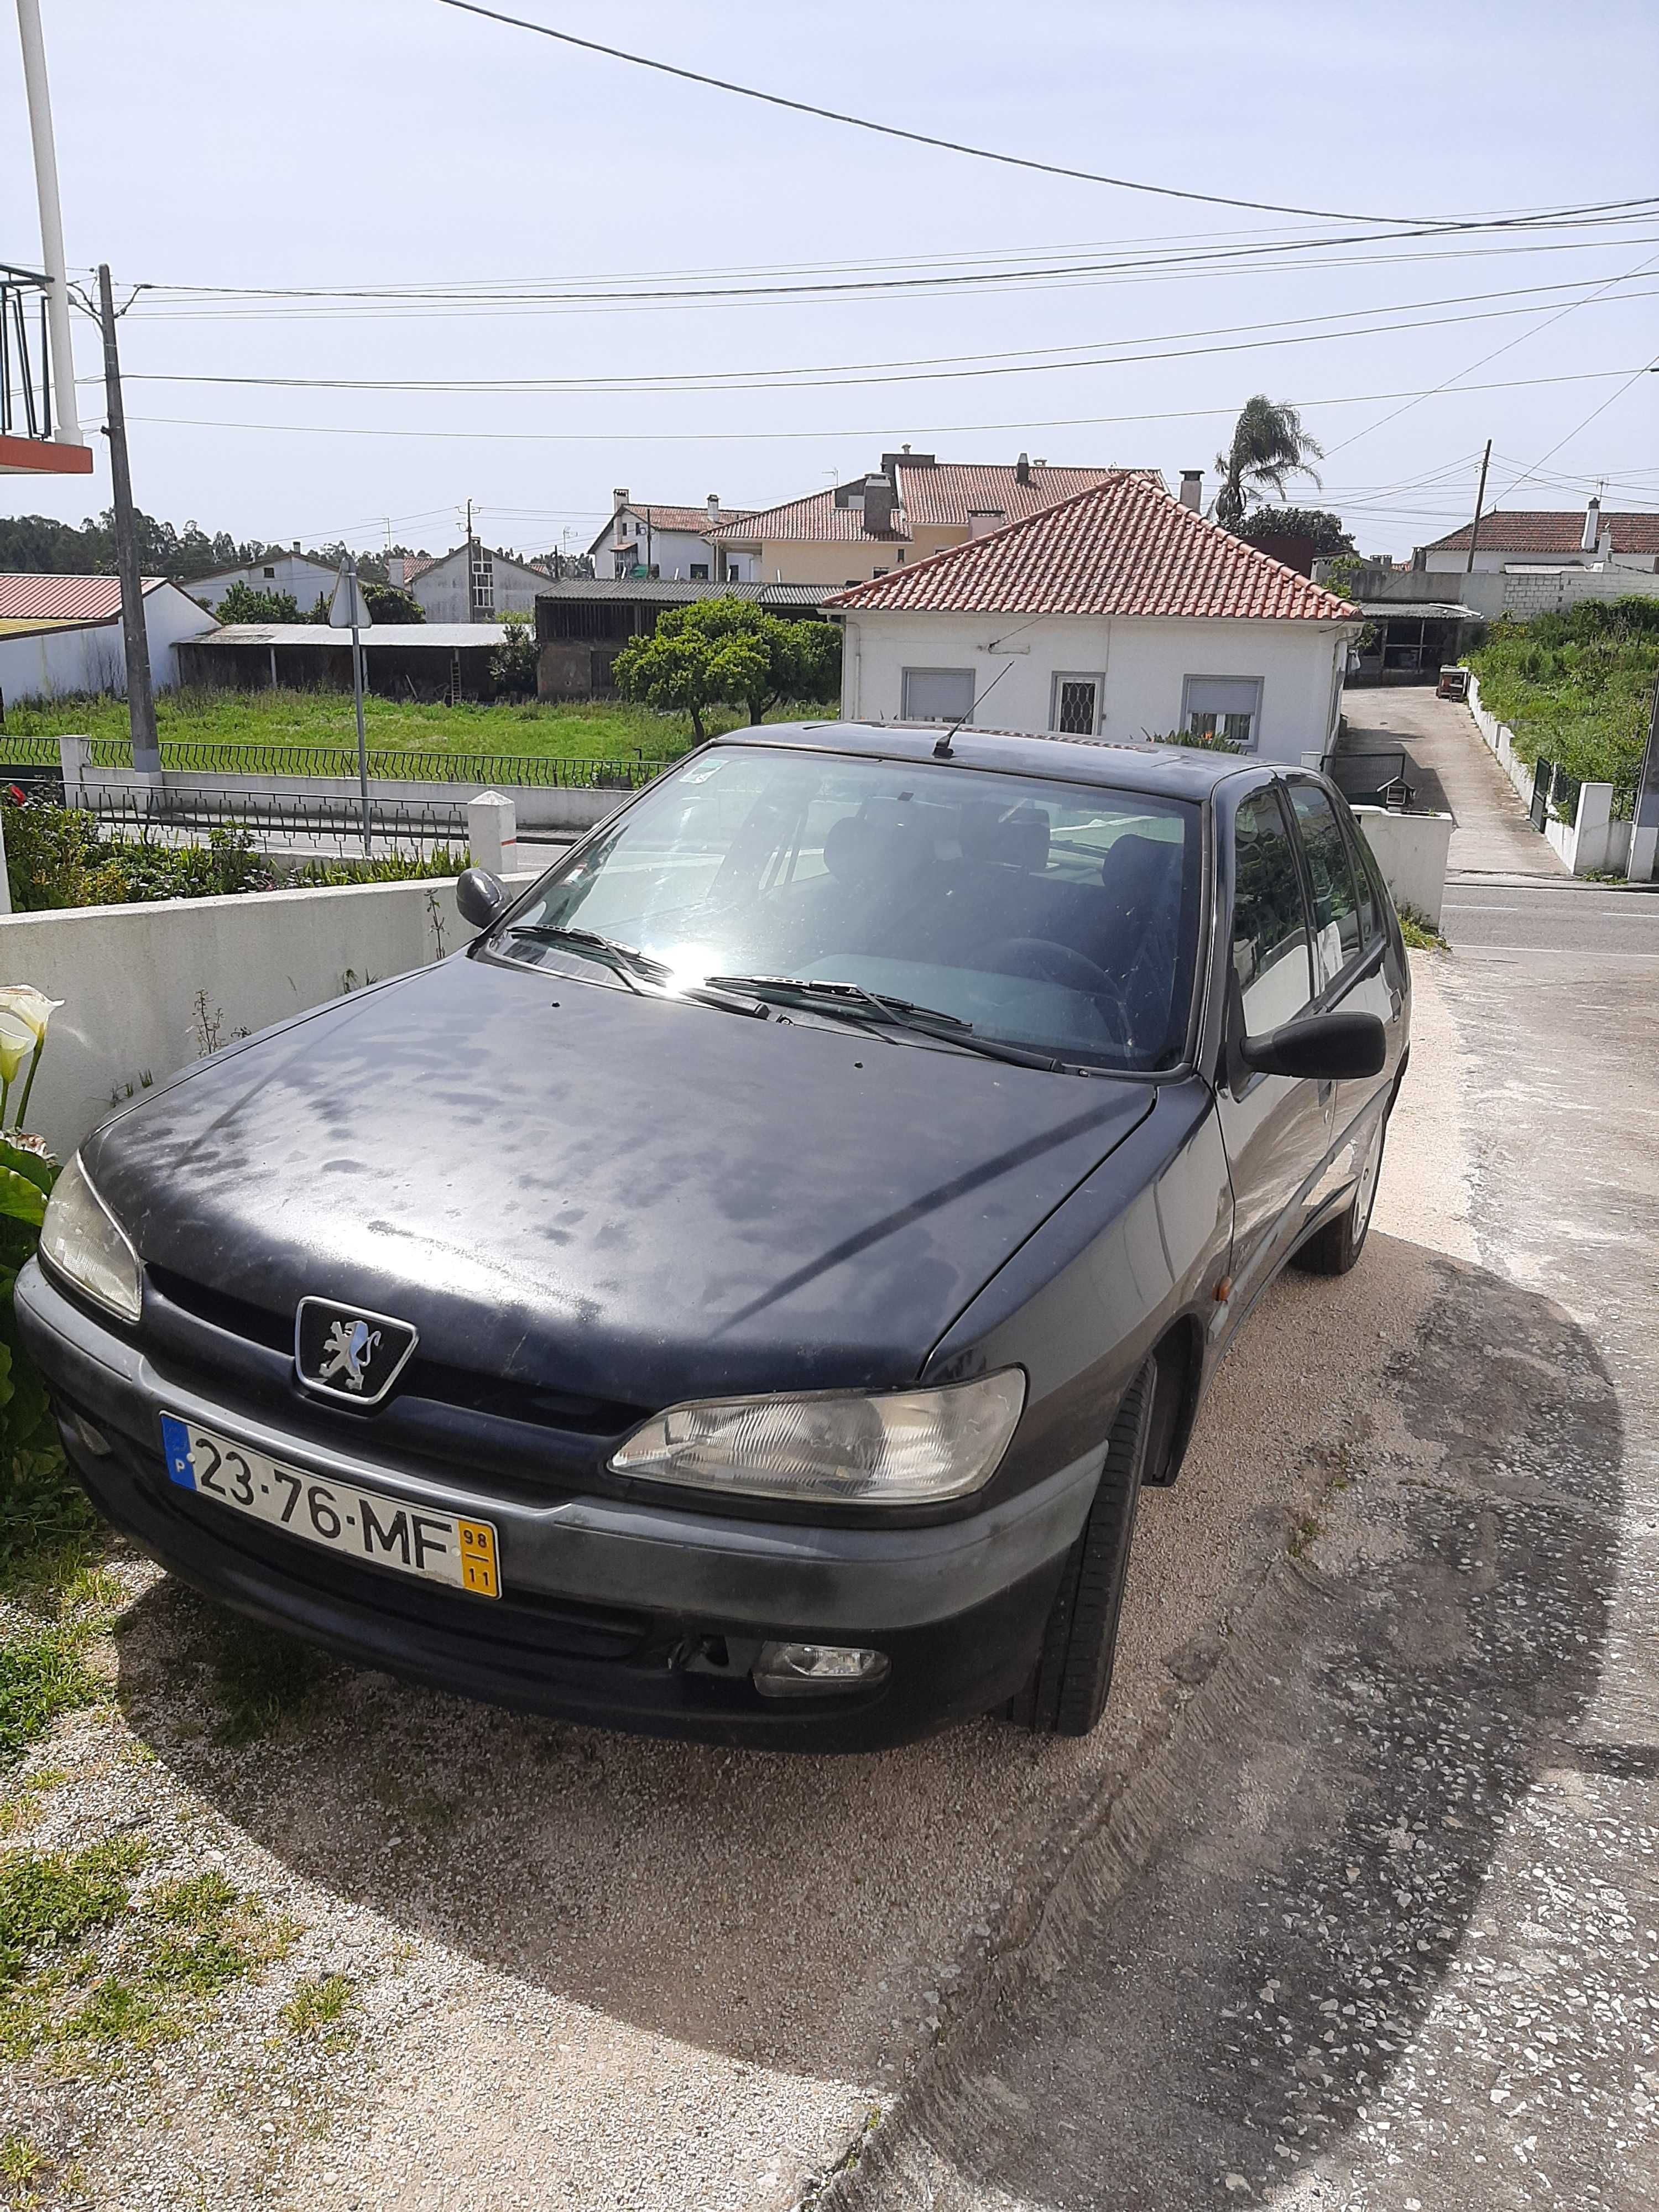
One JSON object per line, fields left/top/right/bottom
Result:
{"left": 1287, "top": 776, "right": 1400, "bottom": 1201}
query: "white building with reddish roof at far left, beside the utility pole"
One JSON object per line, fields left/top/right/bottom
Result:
{"left": 0, "top": 575, "right": 219, "bottom": 712}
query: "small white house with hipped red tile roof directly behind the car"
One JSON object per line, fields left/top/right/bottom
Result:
{"left": 825, "top": 469, "right": 1360, "bottom": 761}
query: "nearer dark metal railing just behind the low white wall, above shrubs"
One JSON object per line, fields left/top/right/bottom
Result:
{"left": 77, "top": 790, "right": 467, "bottom": 858}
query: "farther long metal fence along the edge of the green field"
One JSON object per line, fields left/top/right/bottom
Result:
{"left": 0, "top": 737, "right": 670, "bottom": 792}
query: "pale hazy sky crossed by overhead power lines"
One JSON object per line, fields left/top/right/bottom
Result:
{"left": 0, "top": 0, "right": 1659, "bottom": 555}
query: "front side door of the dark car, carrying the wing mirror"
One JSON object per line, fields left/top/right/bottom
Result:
{"left": 1217, "top": 781, "right": 1329, "bottom": 1316}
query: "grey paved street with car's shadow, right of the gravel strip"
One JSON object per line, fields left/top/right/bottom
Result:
{"left": 830, "top": 699, "right": 1659, "bottom": 2212}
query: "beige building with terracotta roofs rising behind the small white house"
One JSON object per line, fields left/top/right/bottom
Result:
{"left": 710, "top": 451, "right": 1164, "bottom": 591}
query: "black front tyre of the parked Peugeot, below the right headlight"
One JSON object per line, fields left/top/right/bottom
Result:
{"left": 1009, "top": 1360, "right": 1157, "bottom": 1736}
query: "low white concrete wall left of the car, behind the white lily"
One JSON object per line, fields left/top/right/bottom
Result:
{"left": 0, "top": 876, "right": 542, "bottom": 1157}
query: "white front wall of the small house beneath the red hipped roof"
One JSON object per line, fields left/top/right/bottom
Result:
{"left": 843, "top": 611, "right": 1352, "bottom": 761}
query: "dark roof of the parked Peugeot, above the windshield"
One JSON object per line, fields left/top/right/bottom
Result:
{"left": 710, "top": 721, "right": 1270, "bottom": 799}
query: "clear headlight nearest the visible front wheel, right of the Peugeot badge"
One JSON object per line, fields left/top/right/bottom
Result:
{"left": 611, "top": 1367, "right": 1026, "bottom": 1506}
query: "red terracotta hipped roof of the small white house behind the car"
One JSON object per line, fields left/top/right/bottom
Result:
{"left": 825, "top": 469, "right": 1360, "bottom": 622}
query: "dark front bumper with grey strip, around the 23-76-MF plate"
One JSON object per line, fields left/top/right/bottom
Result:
{"left": 15, "top": 1263, "right": 1099, "bottom": 1750}
